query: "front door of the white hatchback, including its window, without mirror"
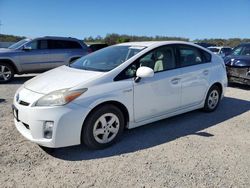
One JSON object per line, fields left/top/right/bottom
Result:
{"left": 134, "top": 46, "right": 181, "bottom": 122}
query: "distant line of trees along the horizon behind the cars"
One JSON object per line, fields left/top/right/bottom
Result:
{"left": 0, "top": 33, "right": 250, "bottom": 47}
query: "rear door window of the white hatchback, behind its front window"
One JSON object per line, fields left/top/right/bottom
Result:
{"left": 178, "top": 45, "right": 211, "bottom": 67}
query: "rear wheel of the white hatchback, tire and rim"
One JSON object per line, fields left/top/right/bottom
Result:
{"left": 203, "top": 85, "right": 221, "bottom": 112}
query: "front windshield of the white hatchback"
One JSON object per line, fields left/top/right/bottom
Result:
{"left": 70, "top": 46, "right": 145, "bottom": 72}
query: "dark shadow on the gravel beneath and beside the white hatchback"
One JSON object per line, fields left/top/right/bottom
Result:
{"left": 45, "top": 97, "right": 250, "bottom": 161}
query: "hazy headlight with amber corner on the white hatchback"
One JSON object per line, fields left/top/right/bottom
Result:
{"left": 35, "top": 88, "right": 88, "bottom": 106}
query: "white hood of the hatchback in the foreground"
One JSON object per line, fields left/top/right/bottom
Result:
{"left": 24, "top": 66, "right": 104, "bottom": 94}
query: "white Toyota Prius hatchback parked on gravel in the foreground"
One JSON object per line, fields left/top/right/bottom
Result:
{"left": 13, "top": 41, "right": 227, "bottom": 149}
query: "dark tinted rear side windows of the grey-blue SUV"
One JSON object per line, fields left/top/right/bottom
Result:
{"left": 49, "top": 40, "right": 82, "bottom": 49}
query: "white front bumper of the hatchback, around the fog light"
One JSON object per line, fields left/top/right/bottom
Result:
{"left": 13, "top": 88, "right": 90, "bottom": 148}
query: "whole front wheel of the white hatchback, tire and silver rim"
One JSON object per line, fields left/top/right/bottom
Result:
{"left": 81, "top": 105, "right": 124, "bottom": 149}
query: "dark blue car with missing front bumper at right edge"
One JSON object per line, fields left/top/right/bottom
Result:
{"left": 224, "top": 43, "right": 250, "bottom": 85}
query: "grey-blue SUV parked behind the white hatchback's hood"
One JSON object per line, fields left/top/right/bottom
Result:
{"left": 0, "top": 37, "right": 88, "bottom": 83}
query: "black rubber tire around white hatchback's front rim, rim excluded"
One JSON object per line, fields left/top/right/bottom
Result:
{"left": 81, "top": 105, "right": 125, "bottom": 149}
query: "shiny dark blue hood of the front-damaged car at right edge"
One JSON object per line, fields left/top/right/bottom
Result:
{"left": 224, "top": 55, "right": 250, "bottom": 67}
